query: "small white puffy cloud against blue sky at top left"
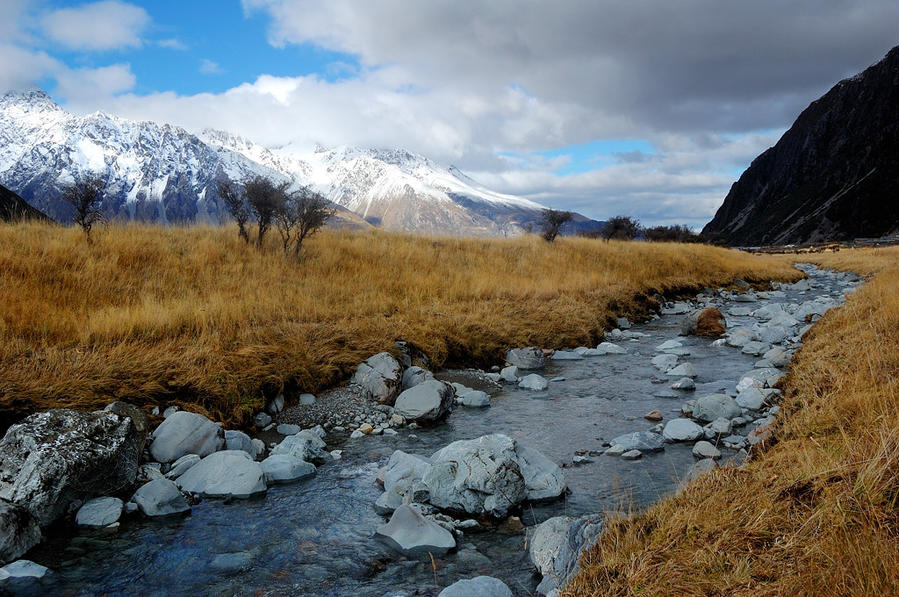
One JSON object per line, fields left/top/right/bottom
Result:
{"left": 42, "top": 0, "right": 150, "bottom": 51}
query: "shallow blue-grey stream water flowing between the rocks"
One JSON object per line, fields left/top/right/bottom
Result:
{"left": 19, "top": 272, "right": 849, "bottom": 597}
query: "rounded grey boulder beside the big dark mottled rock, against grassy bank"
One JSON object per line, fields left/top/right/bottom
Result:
{"left": 150, "top": 410, "right": 225, "bottom": 462}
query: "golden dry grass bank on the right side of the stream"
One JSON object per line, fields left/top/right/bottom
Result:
{"left": 565, "top": 248, "right": 899, "bottom": 596}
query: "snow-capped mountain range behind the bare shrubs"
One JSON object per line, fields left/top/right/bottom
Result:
{"left": 0, "top": 91, "right": 596, "bottom": 236}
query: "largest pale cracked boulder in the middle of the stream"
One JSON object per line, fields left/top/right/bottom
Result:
{"left": 422, "top": 434, "right": 565, "bottom": 517}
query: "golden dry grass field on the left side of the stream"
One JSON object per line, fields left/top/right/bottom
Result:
{"left": 0, "top": 224, "right": 796, "bottom": 424}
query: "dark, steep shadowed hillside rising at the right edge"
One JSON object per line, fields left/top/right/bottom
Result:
{"left": 703, "top": 47, "right": 899, "bottom": 246}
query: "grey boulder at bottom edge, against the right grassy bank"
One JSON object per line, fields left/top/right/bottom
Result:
{"left": 528, "top": 516, "right": 603, "bottom": 595}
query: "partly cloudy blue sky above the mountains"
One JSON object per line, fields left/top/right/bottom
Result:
{"left": 0, "top": 0, "right": 899, "bottom": 227}
